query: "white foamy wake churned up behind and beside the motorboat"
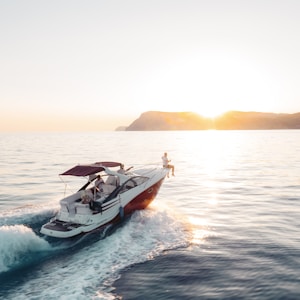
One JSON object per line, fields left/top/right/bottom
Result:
{"left": 0, "top": 206, "right": 189, "bottom": 299}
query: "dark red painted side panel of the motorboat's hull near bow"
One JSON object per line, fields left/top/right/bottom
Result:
{"left": 124, "top": 178, "right": 164, "bottom": 215}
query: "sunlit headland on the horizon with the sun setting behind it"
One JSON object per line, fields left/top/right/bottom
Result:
{"left": 126, "top": 111, "right": 300, "bottom": 131}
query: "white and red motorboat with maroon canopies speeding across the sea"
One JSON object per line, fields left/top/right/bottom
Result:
{"left": 40, "top": 162, "right": 169, "bottom": 238}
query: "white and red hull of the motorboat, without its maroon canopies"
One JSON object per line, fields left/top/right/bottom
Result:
{"left": 41, "top": 163, "right": 168, "bottom": 238}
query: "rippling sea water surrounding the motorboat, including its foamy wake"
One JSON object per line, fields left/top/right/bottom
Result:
{"left": 0, "top": 130, "right": 300, "bottom": 300}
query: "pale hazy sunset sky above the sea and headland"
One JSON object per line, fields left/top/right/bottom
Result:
{"left": 0, "top": 0, "right": 300, "bottom": 131}
